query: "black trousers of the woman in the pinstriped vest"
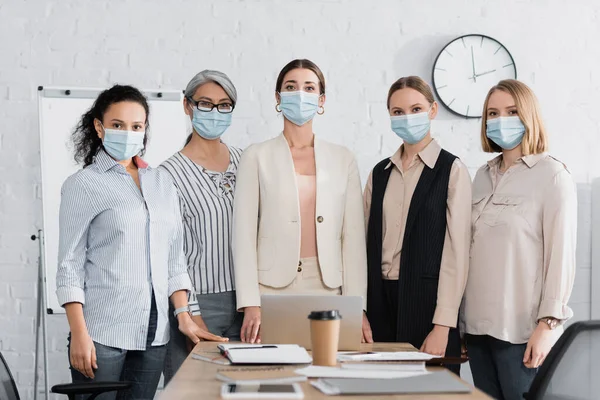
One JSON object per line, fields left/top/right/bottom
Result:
{"left": 383, "top": 279, "right": 461, "bottom": 376}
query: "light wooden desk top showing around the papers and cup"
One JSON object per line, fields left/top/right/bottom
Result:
{"left": 159, "top": 342, "right": 490, "bottom": 400}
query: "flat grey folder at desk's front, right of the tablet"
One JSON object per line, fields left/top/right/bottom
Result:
{"left": 311, "top": 371, "right": 471, "bottom": 395}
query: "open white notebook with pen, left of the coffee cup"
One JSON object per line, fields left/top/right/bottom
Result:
{"left": 218, "top": 344, "right": 312, "bottom": 364}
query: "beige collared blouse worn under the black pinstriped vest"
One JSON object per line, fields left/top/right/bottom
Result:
{"left": 363, "top": 140, "right": 471, "bottom": 327}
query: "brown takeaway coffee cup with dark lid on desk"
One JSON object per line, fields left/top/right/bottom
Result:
{"left": 308, "top": 310, "right": 342, "bottom": 366}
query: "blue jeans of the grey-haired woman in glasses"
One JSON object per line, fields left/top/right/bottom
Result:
{"left": 163, "top": 291, "right": 244, "bottom": 385}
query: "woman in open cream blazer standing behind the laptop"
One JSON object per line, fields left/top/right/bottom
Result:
{"left": 233, "top": 60, "right": 372, "bottom": 343}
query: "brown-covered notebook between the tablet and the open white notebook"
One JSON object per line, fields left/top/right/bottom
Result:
{"left": 217, "top": 367, "right": 306, "bottom": 385}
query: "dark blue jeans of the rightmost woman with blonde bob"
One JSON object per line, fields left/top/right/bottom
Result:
{"left": 466, "top": 335, "right": 537, "bottom": 400}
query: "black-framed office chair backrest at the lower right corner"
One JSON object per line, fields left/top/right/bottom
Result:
{"left": 523, "top": 320, "right": 600, "bottom": 400}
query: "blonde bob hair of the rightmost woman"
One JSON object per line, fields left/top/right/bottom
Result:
{"left": 481, "top": 79, "right": 548, "bottom": 156}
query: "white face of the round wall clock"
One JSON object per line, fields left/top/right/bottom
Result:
{"left": 433, "top": 35, "right": 517, "bottom": 118}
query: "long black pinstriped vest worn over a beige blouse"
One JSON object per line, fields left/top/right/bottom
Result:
{"left": 367, "top": 150, "right": 460, "bottom": 355}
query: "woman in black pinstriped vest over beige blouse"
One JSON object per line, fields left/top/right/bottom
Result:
{"left": 364, "top": 76, "right": 471, "bottom": 373}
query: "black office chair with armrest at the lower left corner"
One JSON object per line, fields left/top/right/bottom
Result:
{"left": 0, "top": 352, "right": 131, "bottom": 400}
